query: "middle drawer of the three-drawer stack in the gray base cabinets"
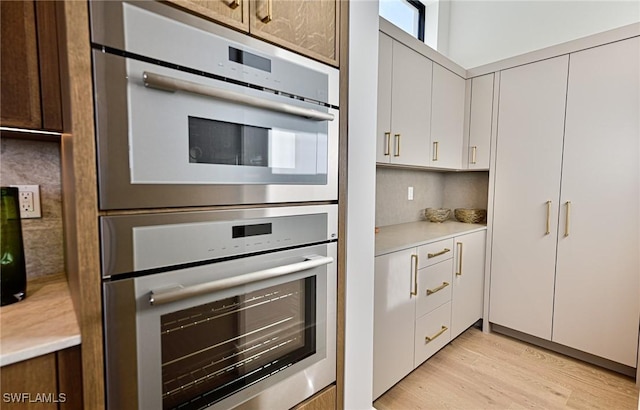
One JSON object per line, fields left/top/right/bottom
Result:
{"left": 416, "top": 259, "right": 453, "bottom": 318}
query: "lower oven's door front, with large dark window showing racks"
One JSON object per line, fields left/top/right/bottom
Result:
{"left": 135, "top": 245, "right": 335, "bottom": 409}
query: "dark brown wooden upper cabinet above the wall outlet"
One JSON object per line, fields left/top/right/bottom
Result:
{"left": 0, "top": 1, "right": 62, "bottom": 131}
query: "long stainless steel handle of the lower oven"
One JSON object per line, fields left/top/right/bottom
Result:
{"left": 149, "top": 255, "right": 333, "bottom": 306}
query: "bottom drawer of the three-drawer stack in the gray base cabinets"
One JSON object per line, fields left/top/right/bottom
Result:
{"left": 414, "top": 302, "right": 451, "bottom": 367}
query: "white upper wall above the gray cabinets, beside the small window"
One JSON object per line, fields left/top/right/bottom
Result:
{"left": 438, "top": 0, "right": 640, "bottom": 68}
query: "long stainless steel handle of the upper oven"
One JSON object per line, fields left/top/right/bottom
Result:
{"left": 142, "top": 71, "right": 334, "bottom": 121}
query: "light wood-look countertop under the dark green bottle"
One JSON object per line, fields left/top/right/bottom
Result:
{"left": 0, "top": 275, "right": 80, "bottom": 366}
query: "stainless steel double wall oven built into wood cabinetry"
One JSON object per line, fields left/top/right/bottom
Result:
{"left": 90, "top": 1, "right": 339, "bottom": 409}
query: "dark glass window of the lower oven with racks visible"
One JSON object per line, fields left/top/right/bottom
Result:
{"left": 161, "top": 276, "right": 316, "bottom": 409}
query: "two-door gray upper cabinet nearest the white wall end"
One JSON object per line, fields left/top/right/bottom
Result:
{"left": 376, "top": 33, "right": 433, "bottom": 166}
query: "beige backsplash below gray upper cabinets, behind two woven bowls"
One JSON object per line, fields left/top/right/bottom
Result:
{"left": 376, "top": 167, "right": 489, "bottom": 226}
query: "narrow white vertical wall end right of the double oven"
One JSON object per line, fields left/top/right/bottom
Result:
{"left": 344, "top": 0, "right": 378, "bottom": 410}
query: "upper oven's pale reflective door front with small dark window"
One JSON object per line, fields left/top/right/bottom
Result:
{"left": 127, "top": 60, "right": 329, "bottom": 185}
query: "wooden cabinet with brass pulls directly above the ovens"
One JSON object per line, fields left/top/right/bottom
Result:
{"left": 167, "top": 0, "right": 340, "bottom": 67}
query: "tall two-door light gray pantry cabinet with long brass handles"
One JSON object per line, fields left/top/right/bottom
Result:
{"left": 489, "top": 38, "right": 640, "bottom": 367}
